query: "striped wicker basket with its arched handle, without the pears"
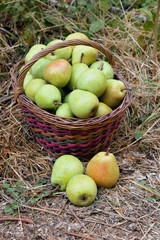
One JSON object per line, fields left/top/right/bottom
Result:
{"left": 10, "top": 39, "right": 131, "bottom": 161}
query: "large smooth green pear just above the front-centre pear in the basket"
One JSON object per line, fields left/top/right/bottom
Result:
{"left": 77, "top": 68, "right": 106, "bottom": 97}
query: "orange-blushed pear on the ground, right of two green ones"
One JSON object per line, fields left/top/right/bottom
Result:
{"left": 86, "top": 152, "right": 119, "bottom": 188}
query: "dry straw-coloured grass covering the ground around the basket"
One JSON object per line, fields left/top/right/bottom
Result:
{"left": 0, "top": 2, "right": 160, "bottom": 240}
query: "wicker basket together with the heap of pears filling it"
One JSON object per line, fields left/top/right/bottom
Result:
{"left": 11, "top": 31, "right": 131, "bottom": 161}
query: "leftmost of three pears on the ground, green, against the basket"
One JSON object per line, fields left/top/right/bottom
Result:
{"left": 51, "top": 154, "right": 84, "bottom": 191}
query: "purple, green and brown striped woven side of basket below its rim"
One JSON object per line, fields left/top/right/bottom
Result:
{"left": 21, "top": 107, "right": 123, "bottom": 158}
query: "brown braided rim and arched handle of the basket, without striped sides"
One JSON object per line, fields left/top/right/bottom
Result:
{"left": 10, "top": 39, "right": 131, "bottom": 129}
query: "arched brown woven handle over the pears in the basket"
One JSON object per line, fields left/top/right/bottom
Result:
{"left": 14, "top": 39, "right": 115, "bottom": 100}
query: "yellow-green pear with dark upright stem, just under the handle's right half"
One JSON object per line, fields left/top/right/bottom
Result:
{"left": 72, "top": 45, "right": 98, "bottom": 66}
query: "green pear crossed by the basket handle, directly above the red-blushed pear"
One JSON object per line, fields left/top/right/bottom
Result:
{"left": 46, "top": 39, "right": 72, "bottom": 61}
